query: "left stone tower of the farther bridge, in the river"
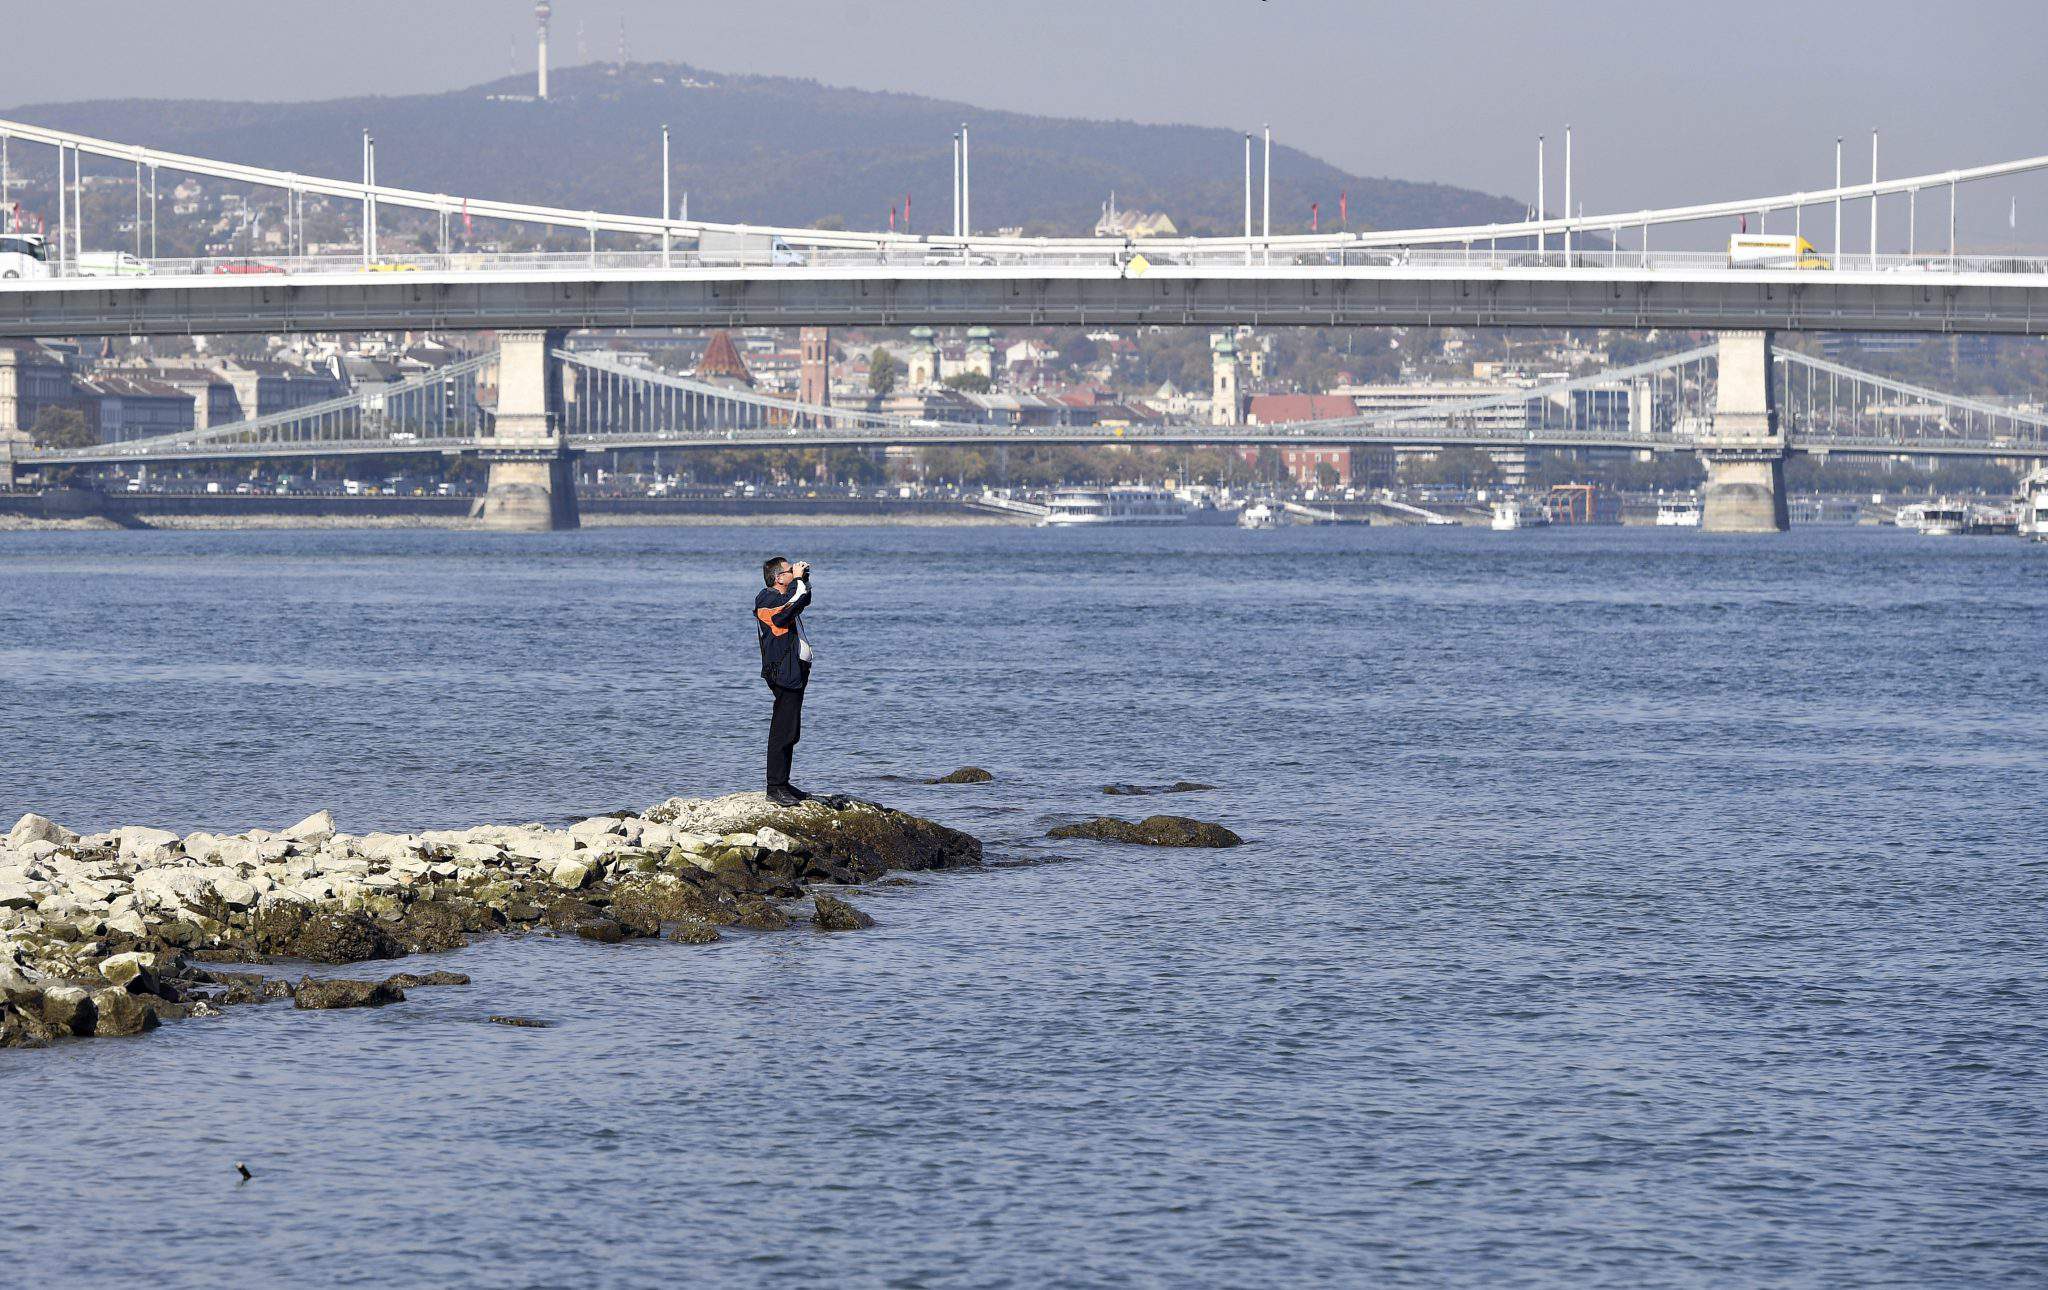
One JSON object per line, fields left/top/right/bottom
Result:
{"left": 477, "top": 332, "right": 582, "bottom": 530}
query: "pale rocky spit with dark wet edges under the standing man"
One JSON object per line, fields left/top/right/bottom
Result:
{"left": 0, "top": 792, "right": 981, "bottom": 1046}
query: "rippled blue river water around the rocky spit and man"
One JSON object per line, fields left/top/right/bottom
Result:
{"left": 0, "top": 528, "right": 2048, "bottom": 1288}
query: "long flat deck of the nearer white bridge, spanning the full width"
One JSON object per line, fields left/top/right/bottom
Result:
{"left": 0, "top": 258, "right": 2048, "bottom": 338}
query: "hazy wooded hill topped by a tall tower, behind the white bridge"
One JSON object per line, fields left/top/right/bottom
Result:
{"left": 0, "top": 63, "right": 1524, "bottom": 233}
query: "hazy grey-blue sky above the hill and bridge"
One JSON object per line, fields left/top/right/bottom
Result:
{"left": 0, "top": 0, "right": 2048, "bottom": 248}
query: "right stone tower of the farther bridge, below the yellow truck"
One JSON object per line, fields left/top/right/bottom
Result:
{"left": 1700, "top": 332, "right": 1792, "bottom": 532}
